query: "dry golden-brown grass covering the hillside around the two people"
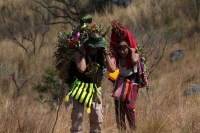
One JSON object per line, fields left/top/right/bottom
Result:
{"left": 0, "top": 0, "right": 200, "bottom": 133}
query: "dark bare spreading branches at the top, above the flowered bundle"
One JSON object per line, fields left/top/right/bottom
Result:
{"left": 29, "top": 0, "right": 95, "bottom": 25}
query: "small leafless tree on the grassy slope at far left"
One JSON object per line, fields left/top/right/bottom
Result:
{"left": 0, "top": 3, "right": 50, "bottom": 56}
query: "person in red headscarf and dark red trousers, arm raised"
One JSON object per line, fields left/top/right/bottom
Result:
{"left": 110, "top": 20, "right": 148, "bottom": 131}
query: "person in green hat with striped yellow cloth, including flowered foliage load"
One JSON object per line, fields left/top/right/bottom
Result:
{"left": 56, "top": 15, "right": 116, "bottom": 133}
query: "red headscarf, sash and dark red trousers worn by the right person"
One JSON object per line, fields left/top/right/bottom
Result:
{"left": 110, "top": 20, "right": 138, "bottom": 130}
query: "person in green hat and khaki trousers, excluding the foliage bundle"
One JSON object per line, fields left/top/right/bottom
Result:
{"left": 70, "top": 34, "right": 115, "bottom": 133}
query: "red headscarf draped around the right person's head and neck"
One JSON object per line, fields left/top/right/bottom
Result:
{"left": 110, "top": 29, "right": 136, "bottom": 69}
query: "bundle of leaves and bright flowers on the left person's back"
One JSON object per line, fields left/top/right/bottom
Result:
{"left": 55, "top": 15, "right": 110, "bottom": 85}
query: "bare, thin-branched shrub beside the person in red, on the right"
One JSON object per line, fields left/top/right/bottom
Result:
{"left": 135, "top": 30, "right": 180, "bottom": 78}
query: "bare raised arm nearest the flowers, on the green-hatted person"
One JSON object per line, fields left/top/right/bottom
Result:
{"left": 74, "top": 45, "right": 86, "bottom": 73}
